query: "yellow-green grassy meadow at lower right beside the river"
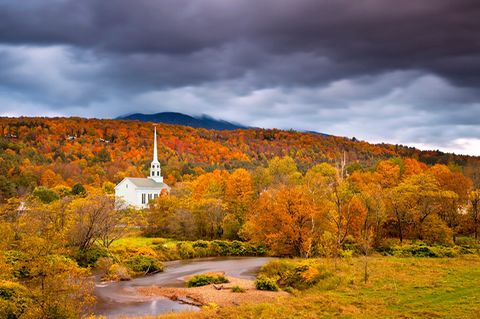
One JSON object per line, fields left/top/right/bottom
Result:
{"left": 142, "top": 255, "right": 480, "bottom": 319}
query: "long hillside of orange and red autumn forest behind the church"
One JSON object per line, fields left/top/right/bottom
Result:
{"left": 0, "top": 117, "right": 480, "bottom": 200}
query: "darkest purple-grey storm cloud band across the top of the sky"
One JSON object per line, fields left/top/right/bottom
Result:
{"left": 0, "top": 0, "right": 480, "bottom": 85}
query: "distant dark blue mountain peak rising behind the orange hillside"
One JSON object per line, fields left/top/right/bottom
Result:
{"left": 116, "top": 112, "right": 248, "bottom": 131}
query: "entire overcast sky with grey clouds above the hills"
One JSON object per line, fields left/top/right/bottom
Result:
{"left": 0, "top": 0, "right": 480, "bottom": 155}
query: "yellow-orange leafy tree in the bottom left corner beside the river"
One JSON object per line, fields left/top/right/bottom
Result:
{"left": 0, "top": 200, "right": 94, "bottom": 318}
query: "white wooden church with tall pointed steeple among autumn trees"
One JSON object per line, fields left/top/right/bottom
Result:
{"left": 115, "top": 127, "right": 170, "bottom": 209}
